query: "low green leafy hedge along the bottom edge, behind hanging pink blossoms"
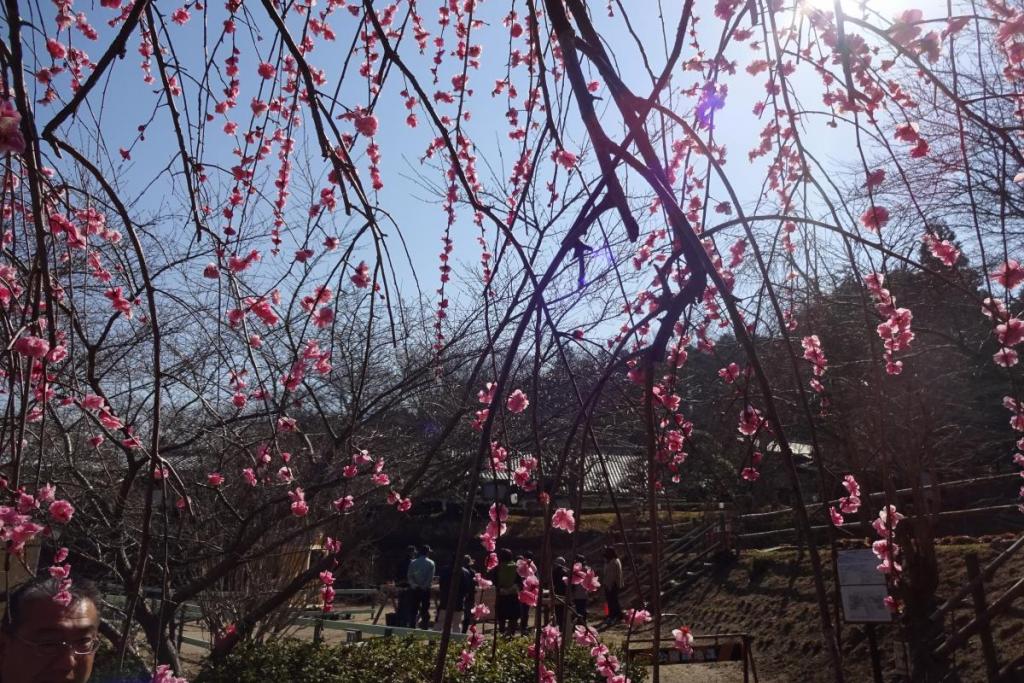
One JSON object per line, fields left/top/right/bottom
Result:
{"left": 196, "top": 638, "right": 646, "bottom": 683}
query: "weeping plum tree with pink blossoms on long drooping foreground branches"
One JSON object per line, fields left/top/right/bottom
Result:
{"left": 0, "top": 0, "right": 1024, "bottom": 682}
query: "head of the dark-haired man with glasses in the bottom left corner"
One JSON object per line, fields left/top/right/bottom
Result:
{"left": 0, "top": 596, "right": 99, "bottom": 683}
